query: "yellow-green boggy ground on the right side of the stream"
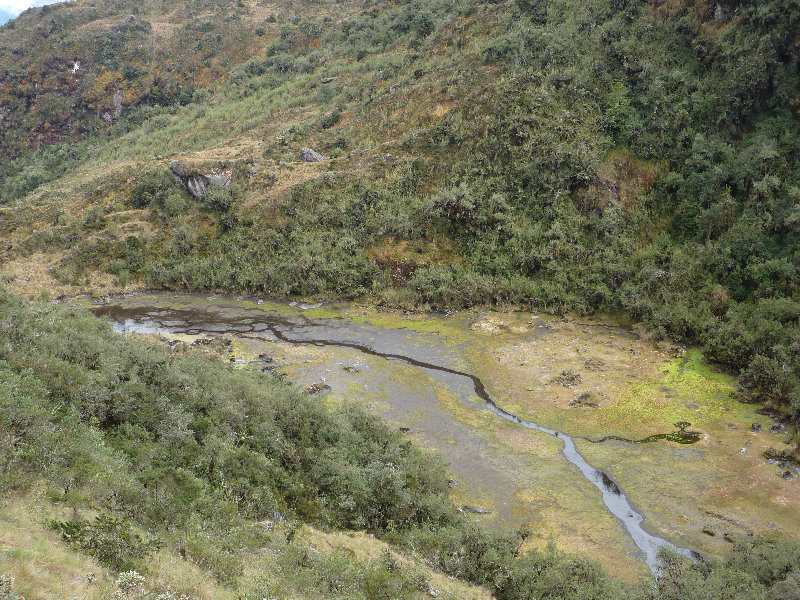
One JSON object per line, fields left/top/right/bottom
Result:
{"left": 462, "top": 314, "right": 800, "bottom": 568}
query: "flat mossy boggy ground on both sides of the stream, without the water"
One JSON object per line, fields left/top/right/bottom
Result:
{"left": 89, "top": 294, "right": 800, "bottom": 579}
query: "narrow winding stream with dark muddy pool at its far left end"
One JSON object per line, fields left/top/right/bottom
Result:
{"left": 91, "top": 294, "right": 699, "bottom": 573}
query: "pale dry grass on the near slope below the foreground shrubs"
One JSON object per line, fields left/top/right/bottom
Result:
{"left": 0, "top": 491, "right": 492, "bottom": 600}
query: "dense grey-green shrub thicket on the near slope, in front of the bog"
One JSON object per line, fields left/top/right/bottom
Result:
{"left": 0, "top": 289, "right": 800, "bottom": 600}
